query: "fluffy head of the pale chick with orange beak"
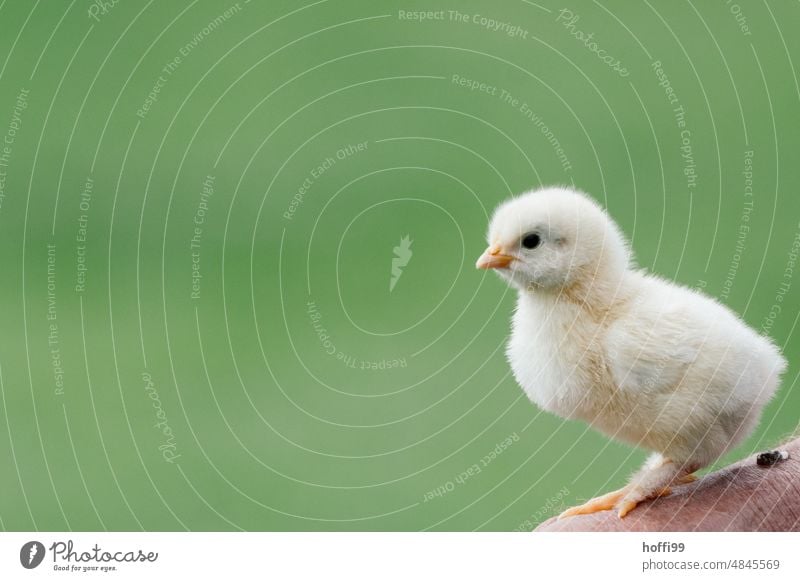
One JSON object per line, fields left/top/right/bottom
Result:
{"left": 475, "top": 188, "right": 630, "bottom": 291}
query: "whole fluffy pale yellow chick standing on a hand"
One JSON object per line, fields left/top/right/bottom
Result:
{"left": 476, "top": 188, "right": 786, "bottom": 517}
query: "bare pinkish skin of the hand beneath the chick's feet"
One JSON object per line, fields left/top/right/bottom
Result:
{"left": 536, "top": 438, "right": 800, "bottom": 532}
